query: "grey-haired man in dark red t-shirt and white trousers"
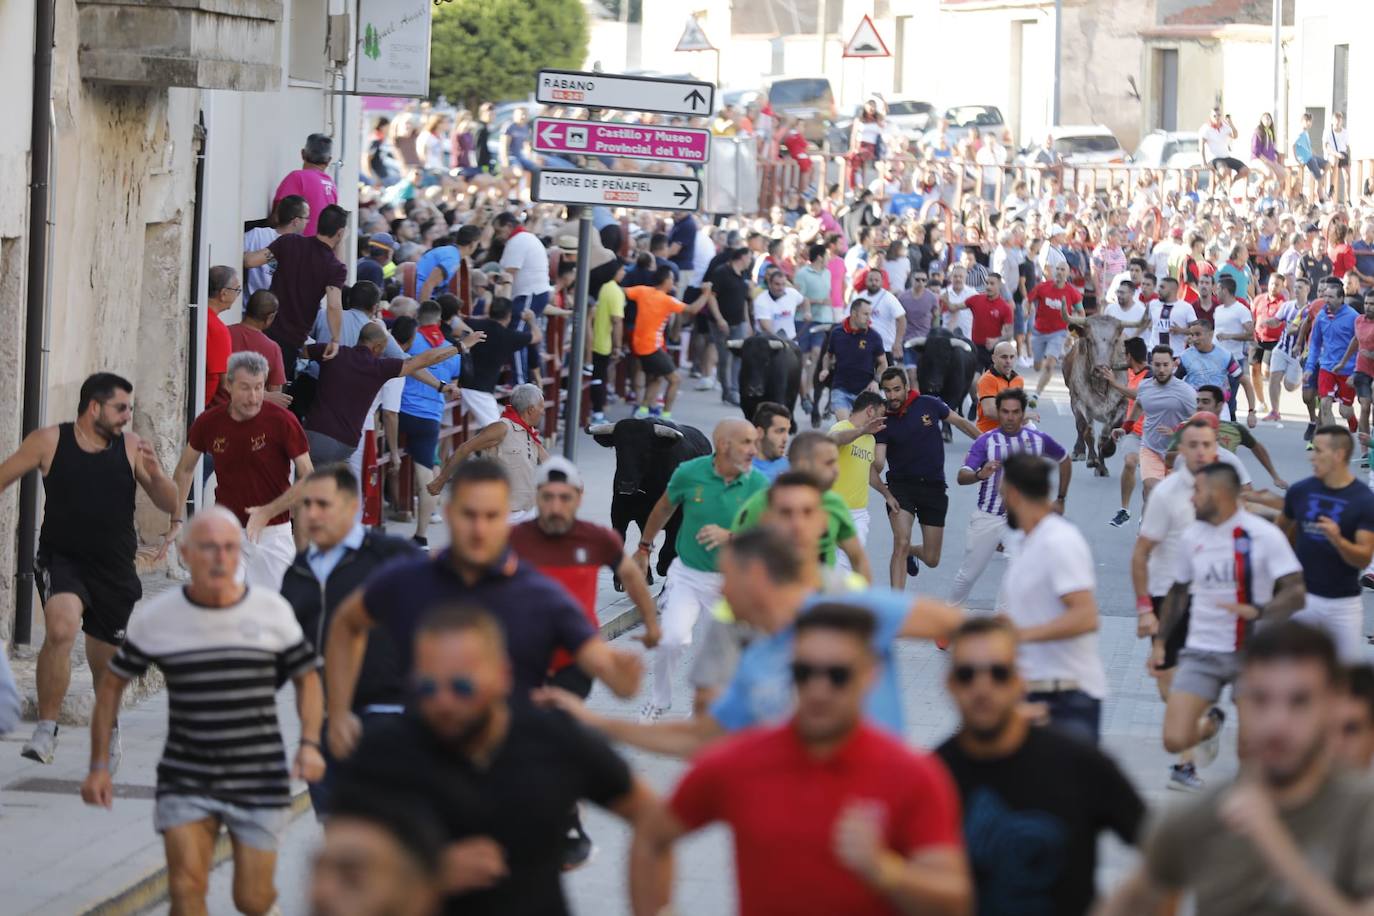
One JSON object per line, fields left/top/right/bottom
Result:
{"left": 172, "top": 352, "right": 312, "bottom": 592}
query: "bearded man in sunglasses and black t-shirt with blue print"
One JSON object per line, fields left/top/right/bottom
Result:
{"left": 936, "top": 617, "right": 1145, "bottom": 916}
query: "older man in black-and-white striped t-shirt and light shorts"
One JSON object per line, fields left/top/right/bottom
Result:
{"left": 81, "top": 505, "right": 324, "bottom": 913}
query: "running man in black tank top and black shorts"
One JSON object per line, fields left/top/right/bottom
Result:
{"left": 0, "top": 372, "right": 181, "bottom": 769}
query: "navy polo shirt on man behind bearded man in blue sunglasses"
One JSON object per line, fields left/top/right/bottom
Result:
{"left": 363, "top": 551, "right": 596, "bottom": 692}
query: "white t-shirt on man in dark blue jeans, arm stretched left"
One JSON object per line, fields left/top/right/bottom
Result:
{"left": 999, "top": 512, "right": 1107, "bottom": 699}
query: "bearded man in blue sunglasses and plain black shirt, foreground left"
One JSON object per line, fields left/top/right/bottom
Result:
{"left": 337, "top": 606, "right": 654, "bottom": 916}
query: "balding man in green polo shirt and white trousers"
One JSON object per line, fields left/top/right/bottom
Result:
{"left": 635, "top": 419, "right": 768, "bottom": 721}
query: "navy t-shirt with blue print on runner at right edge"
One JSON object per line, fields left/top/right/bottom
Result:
{"left": 1283, "top": 477, "right": 1374, "bottom": 597}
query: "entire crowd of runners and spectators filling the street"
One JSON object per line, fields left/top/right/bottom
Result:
{"left": 0, "top": 96, "right": 1374, "bottom": 916}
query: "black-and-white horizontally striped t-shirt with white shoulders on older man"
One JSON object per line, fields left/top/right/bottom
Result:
{"left": 110, "top": 588, "right": 316, "bottom": 808}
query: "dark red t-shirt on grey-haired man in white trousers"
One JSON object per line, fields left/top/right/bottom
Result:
{"left": 187, "top": 401, "right": 311, "bottom": 525}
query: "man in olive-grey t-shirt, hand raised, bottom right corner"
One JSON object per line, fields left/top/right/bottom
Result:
{"left": 1101, "top": 621, "right": 1374, "bottom": 916}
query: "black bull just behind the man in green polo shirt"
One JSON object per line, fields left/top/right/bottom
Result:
{"left": 588, "top": 417, "right": 710, "bottom": 589}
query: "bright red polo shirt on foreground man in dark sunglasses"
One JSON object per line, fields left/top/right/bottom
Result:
{"left": 669, "top": 722, "right": 963, "bottom": 916}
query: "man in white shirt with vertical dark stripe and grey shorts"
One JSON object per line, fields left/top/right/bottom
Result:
{"left": 1154, "top": 464, "right": 1304, "bottom": 766}
